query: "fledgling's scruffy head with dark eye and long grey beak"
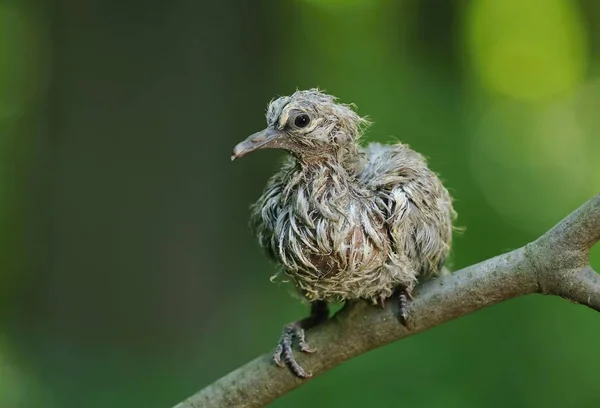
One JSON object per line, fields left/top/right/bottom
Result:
{"left": 231, "top": 89, "right": 368, "bottom": 162}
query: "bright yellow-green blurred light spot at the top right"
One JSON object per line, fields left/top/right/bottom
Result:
{"left": 466, "top": 0, "right": 587, "bottom": 100}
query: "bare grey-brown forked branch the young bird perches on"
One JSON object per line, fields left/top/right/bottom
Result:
{"left": 175, "top": 194, "right": 600, "bottom": 408}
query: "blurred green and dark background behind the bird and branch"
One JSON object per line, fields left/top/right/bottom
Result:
{"left": 0, "top": 0, "right": 600, "bottom": 408}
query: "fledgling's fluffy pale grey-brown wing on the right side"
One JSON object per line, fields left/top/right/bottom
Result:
{"left": 358, "top": 143, "right": 454, "bottom": 275}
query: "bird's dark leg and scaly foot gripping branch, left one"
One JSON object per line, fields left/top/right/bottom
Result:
{"left": 273, "top": 301, "right": 329, "bottom": 378}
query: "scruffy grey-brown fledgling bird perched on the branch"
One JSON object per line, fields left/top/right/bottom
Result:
{"left": 231, "top": 88, "right": 456, "bottom": 378}
